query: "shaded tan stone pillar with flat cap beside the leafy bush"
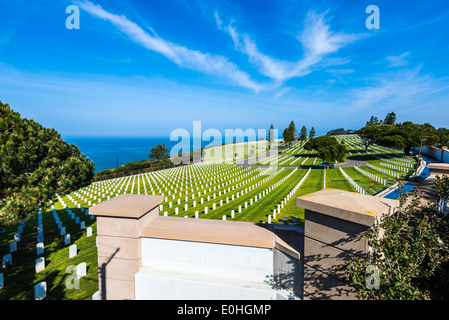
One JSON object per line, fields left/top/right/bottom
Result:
{"left": 296, "top": 189, "right": 398, "bottom": 300}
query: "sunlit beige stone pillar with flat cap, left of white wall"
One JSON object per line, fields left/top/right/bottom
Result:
{"left": 89, "top": 194, "right": 163, "bottom": 300}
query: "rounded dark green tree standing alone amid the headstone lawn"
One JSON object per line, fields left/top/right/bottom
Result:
{"left": 304, "top": 136, "right": 346, "bottom": 162}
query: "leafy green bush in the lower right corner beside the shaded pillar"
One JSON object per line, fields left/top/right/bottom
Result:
{"left": 339, "top": 180, "right": 449, "bottom": 300}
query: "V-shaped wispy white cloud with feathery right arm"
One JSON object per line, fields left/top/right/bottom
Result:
{"left": 215, "top": 11, "right": 360, "bottom": 85}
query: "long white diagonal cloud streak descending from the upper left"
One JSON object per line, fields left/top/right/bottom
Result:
{"left": 77, "top": 1, "right": 262, "bottom": 92}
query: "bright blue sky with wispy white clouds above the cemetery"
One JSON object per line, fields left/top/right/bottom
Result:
{"left": 0, "top": 0, "right": 449, "bottom": 136}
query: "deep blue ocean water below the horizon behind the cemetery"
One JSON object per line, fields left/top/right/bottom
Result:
{"left": 63, "top": 136, "right": 256, "bottom": 172}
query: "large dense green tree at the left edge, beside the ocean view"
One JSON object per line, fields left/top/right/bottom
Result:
{"left": 0, "top": 102, "right": 95, "bottom": 225}
